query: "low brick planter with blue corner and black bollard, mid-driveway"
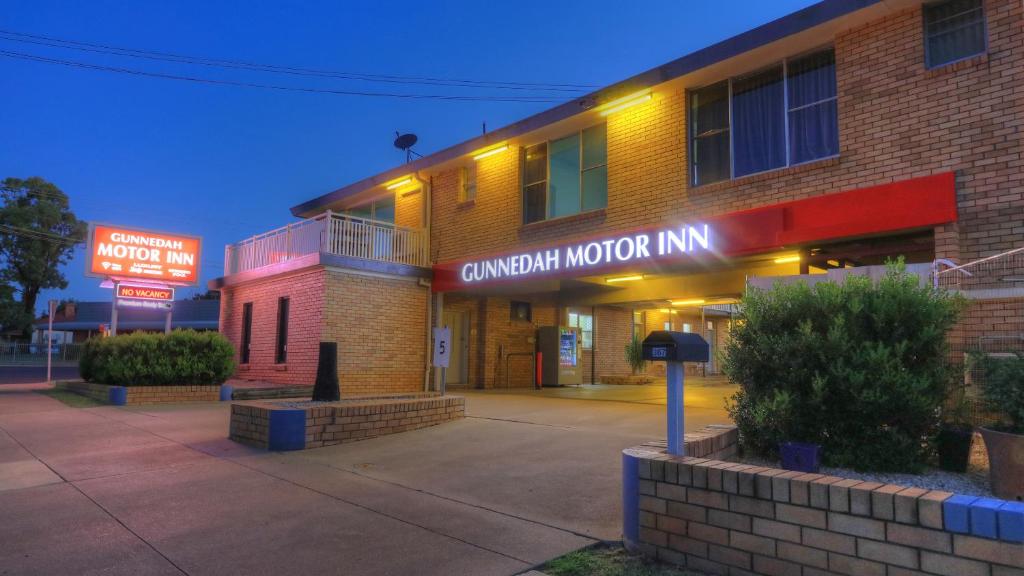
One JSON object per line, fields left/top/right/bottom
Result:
{"left": 229, "top": 395, "right": 466, "bottom": 450}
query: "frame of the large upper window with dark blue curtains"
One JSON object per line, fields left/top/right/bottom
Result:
{"left": 686, "top": 44, "right": 842, "bottom": 188}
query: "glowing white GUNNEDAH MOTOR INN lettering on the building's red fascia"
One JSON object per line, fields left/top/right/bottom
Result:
{"left": 459, "top": 224, "right": 712, "bottom": 284}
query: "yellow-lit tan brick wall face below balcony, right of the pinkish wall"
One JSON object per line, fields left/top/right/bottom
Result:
{"left": 323, "top": 269, "right": 428, "bottom": 394}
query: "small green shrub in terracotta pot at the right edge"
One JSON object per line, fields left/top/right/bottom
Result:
{"left": 971, "top": 353, "right": 1024, "bottom": 434}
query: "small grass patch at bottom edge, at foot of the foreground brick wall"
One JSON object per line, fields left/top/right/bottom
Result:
{"left": 541, "top": 545, "right": 700, "bottom": 576}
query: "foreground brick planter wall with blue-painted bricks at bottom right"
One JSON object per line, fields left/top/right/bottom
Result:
{"left": 624, "top": 446, "right": 1024, "bottom": 576}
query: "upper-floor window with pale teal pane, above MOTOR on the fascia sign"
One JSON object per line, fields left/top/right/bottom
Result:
{"left": 522, "top": 124, "right": 608, "bottom": 223}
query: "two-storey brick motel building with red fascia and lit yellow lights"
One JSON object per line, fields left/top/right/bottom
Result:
{"left": 210, "top": 0, "right": 1024, "bottom": 393}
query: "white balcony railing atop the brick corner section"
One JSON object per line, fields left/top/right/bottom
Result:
{"left": 224, "top": 211, "right": 430, "bottom": 275}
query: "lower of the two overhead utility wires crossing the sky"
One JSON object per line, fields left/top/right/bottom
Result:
{"left": 0, "top": 50, "right": 567, "bottom": 102}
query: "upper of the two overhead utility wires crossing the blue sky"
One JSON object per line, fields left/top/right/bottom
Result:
{"left": 0, "top": 29, "right": 598, "bottom": 92}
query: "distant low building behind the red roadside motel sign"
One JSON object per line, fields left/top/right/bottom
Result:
{"left": 32, "top": 300, "right": 220, "bottom": 343}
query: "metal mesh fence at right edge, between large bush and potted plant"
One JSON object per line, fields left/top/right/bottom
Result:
{"left": 932, "top": 243, "right": 1024, "bottom": 424}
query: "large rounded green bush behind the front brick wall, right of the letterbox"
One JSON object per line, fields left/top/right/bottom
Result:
{"left": 723, "top": 261, "right": 963, "bottom": 471}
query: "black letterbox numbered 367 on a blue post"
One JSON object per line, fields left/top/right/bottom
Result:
{"left": 643, "top": 330, "right": 711, "bottom": 456}
